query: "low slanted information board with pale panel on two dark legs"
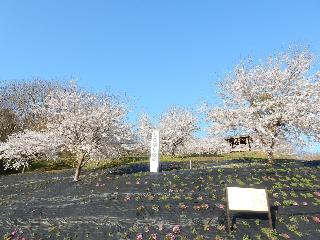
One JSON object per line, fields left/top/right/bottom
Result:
{"left": 226, "top": 187, "right": 272, "bottom": 231}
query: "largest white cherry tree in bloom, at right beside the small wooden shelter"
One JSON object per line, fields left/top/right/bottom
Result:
{"left": 207, "top": 48, "right": 320, "bottom": 163}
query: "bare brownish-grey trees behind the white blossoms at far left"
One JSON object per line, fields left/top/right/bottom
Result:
{"left": 0, "top": 78, "right": 65, "bottom": 134}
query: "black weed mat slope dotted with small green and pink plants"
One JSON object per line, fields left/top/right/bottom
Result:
{"left": 0, "top": 160, "right": 320, "bottom": 240}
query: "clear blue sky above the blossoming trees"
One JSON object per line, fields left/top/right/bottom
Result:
{"left": 0, "top": 0, "right": 320, "bottom": 121}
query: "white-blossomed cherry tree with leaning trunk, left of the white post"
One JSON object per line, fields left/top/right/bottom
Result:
{"left": 39, "top": 83, "right": 133, "bottom": 181}
